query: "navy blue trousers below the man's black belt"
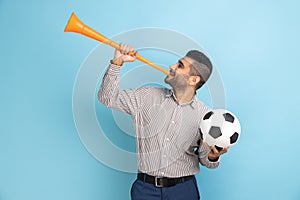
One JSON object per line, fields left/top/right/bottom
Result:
{"left": 131, "top": 177, "right": 200, "bottom": 200}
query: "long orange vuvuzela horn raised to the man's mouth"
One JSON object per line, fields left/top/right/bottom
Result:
{"left": 64, "top": 12, "right": 169, "bottom": 74}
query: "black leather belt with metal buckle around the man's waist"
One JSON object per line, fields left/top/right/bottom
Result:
{"left": 137, "top": 173, "right": 194, "bottom": 187}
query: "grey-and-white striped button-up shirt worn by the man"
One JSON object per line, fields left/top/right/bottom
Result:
{"left": 98, "top": 64, "right": 219, "bottom": 177}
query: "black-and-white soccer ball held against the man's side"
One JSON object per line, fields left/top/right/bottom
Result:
{"left": 200, "top": 109, "right": 241, "bottom": 150}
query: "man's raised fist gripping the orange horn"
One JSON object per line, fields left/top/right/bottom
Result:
{"left": 111, "top": 43, "right": 138, "bottom": 66}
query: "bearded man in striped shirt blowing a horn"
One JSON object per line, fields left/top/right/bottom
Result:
{"left": 98, "top": 44, "right": 227, "bottom": 200}
